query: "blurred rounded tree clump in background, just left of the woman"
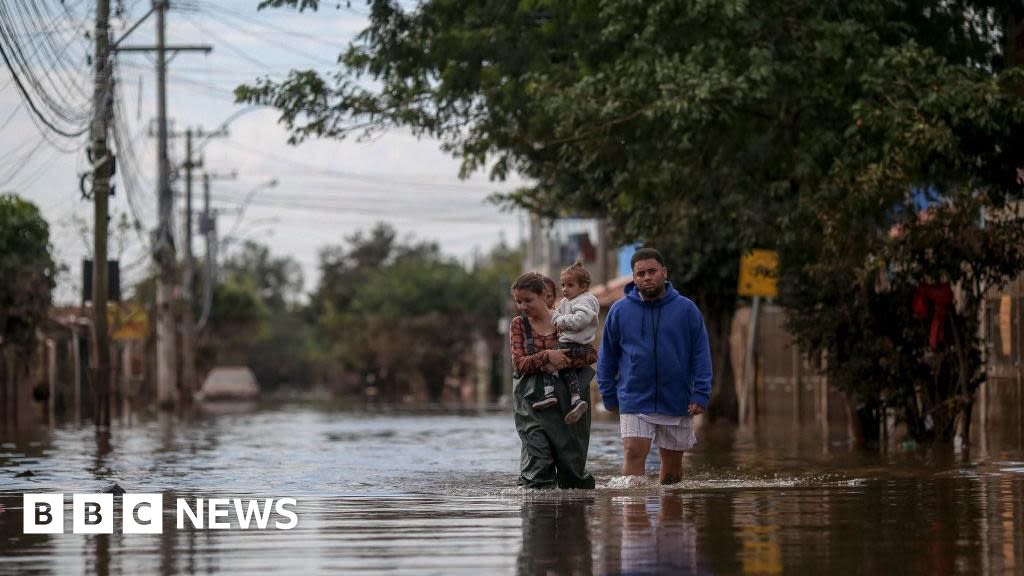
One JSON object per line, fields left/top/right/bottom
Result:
{"left": 313, "top": 220, "right": 516, "bottom": 400}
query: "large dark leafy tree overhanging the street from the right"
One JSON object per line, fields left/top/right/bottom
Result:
{"left": 237, "top": 0, "right": 1022, "bottom": 440}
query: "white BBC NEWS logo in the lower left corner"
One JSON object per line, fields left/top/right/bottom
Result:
{"left": 23, "top": 494, "right": 299, "bottom": 534}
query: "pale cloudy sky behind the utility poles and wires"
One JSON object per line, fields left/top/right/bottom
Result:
{"left": 0, "top": 0, "right": 524, "bottom": 303}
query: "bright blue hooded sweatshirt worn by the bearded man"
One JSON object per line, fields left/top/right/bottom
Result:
{"left": 597, "top": 282, "right": 711, "bottom": 416}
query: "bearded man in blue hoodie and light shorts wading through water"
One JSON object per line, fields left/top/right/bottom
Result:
{"left": 597, "top": 248, "right": 711, "bottom": 484}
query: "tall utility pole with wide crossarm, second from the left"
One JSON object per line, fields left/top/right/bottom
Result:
{"left": 118, "top": 0, "right": 213, "bottom": 409}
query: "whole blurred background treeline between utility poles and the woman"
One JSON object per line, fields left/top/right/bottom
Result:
{"left": 201, "top": 223, "right": 520, "bottom": 401}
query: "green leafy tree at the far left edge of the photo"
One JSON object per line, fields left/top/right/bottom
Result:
{"left": 0, "top": 194, "right": 56, "bottom": 352}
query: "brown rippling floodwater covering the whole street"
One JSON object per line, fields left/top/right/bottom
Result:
{"left": 0, "top": 405, "right": 1024, "bottom": 575}
